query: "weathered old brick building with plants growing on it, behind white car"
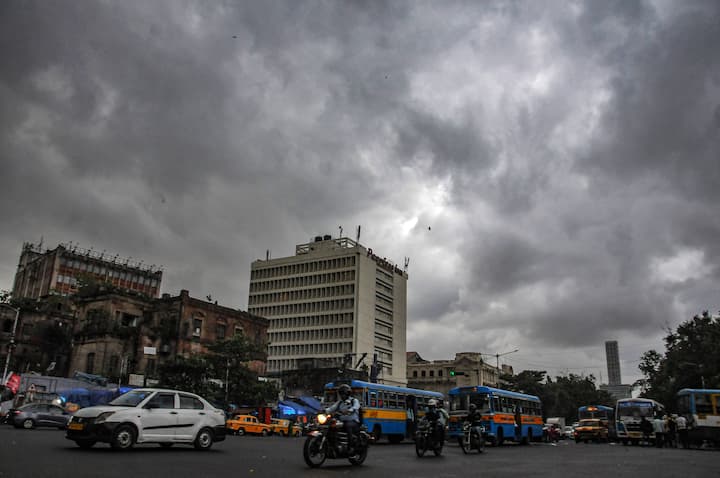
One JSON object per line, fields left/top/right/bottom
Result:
{"left": 70, "top": 290, "right": 267, "bottom": 382}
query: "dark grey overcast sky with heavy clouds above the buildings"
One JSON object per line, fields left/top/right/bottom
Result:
{"left": 0, "top": 0, "right": 720, "bottom": 382}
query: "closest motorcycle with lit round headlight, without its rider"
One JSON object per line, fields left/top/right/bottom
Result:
{"left": 303, "top": 413, "right": 370, "bottom": 468}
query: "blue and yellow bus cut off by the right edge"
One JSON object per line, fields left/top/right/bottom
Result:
{"left": 676, "top": 388, "right": 720, "bottom": 446}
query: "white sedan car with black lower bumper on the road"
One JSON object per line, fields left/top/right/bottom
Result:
{"left": 65, "top": 388, "right": 225, "bottom": 450}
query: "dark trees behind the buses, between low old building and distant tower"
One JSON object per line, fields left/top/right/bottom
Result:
{"left": 502, "top": 370, "right": 615, "bottom": 421}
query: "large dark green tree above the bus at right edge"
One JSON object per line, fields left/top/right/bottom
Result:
{"left": 636, "top": 311, "right": 720, "bottom": 409}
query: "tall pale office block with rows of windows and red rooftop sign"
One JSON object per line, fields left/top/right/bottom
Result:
{"left": 248, "top": 235, "right": 407, "bottom": 385}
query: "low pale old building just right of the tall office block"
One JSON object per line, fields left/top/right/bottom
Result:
{"left": 407, "top": 352, "right": 505, "bottom": 395}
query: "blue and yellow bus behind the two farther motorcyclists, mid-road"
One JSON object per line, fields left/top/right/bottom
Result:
{"left": 448, "top": 385, "right": 543, "bottom": 446}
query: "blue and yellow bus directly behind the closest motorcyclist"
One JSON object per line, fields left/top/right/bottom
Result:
{"left": 323, "top": 380, "right": 444, "bottom": 443}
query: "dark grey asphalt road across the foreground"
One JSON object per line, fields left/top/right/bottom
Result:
{"left": 0, "top": 425, "right": 720, "bottom": 478}
